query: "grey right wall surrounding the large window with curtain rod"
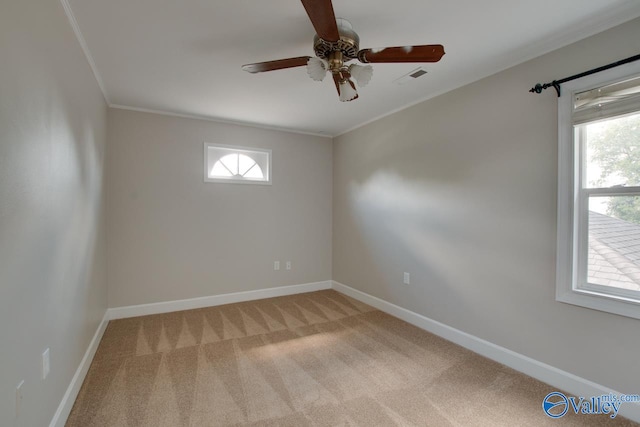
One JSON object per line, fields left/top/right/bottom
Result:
{"left": 333, "top": 20, "right": 640, "bottom": 393}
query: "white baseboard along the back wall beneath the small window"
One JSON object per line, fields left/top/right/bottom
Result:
{"left": 107, "top": 280, "right": 332, "bottom": 319}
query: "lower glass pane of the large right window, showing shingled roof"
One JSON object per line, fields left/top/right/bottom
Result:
{"left": 587, "top": 196, "right": 640, "bottom": 291}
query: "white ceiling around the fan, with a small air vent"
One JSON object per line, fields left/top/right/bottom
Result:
{"left": 62, "top": 0, "right": 640, "bottom": 136}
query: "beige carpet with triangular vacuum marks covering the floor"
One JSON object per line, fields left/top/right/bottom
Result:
{"left": 67, "top": 290, "right": 636, "bottom": 427}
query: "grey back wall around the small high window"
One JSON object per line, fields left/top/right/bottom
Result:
{"left": 107, "top": 109, "right": 332, "bottom": 307}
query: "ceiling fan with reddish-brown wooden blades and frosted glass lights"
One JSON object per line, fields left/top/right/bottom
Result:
{"left": 242, "top": 0, "right": 444, "bottom": 102}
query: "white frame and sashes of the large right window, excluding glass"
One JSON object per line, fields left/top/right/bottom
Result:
{"left": 556, "top": 62, "right": 640, "bottom": 319}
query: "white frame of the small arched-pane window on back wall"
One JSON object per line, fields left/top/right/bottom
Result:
{"left": 204, "top": 142, "right": 273, "bottom": 185}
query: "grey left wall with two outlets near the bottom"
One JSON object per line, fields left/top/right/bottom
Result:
{"left": 0, "top": 0, "right": 107, "bottom": 426}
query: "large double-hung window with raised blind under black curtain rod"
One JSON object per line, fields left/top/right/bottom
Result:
{"left": 556, "top": 63, "right": 640, "bottom": 319}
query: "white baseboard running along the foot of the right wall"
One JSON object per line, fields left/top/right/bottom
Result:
{"left": 331, "top": 281, "right": 640, "bottom": 422}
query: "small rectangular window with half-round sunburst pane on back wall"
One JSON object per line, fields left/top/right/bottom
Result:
{"left": 204, "top": 142, "right": 271, "bottom": 184}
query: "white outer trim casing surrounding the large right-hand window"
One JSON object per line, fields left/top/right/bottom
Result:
{"left": 556, "top": 62, "right": 640, "bottom": 319}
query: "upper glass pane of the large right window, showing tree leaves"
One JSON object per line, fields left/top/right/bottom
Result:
{"left": 582, "top": 113, "right": 640, "bottom": 188}
